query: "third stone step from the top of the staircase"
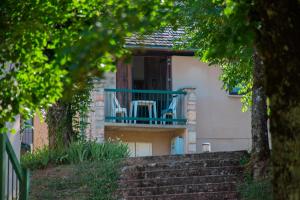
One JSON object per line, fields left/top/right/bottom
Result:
{"left": 120, "top": 166, "right": 243, "bottom": 180}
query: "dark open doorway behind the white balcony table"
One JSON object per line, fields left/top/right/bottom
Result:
{"left": 132, "top": 56, "right": 172, "bottom": 123}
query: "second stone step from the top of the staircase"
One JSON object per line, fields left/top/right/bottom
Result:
{"left": 122, "top": 159, "right": 240, "bottom": 173}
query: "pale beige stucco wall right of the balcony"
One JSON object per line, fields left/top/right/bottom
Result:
{"left": 172, "top": 56, "right": 251, "bottom": 152}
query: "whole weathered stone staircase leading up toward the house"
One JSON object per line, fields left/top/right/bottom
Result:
{"left": 118, "top": 151, "right": 246, "bottom": 200}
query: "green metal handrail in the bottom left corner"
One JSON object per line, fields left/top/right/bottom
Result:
{"left": 0, "top": 133, "right": 29, "bottom": 200}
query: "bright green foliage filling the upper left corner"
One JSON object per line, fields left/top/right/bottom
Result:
{"left": 0, "top": 0, "right": 173, "bottom": 132}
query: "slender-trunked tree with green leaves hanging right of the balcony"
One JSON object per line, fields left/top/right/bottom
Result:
{"left": 179, "top": 0, "right": 270, "bottom": 178}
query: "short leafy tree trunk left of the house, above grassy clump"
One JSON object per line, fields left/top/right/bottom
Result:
{"left": 46, "top": 102, "right": 74, "bottom": 148}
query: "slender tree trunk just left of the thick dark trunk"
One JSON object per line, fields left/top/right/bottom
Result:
{"left": 251, "top": 49, "right": 270, "bottom": 179}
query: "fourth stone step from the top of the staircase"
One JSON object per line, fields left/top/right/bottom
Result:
{"left": 119, "top": 175, "right": 241, "bottom": 188}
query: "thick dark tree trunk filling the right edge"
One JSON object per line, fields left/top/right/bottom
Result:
{"left": 255, "top": 0, "right": 300, "bottom": 200}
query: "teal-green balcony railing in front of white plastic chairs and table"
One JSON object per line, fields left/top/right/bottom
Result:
{"left": 105, "top": 89, "right": 186, "bottom": 125}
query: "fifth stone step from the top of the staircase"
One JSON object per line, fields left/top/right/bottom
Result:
{"left": 119, "top": 182, "right": 236, "bottom": 196}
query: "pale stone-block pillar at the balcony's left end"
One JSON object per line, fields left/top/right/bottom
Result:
{"left": 87, "top": 72, "right": 116, "bottom": 142}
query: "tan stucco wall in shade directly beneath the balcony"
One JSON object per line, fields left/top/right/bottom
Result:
{"left": 105, "top": 129, "right": 184, "bottom": 156}
